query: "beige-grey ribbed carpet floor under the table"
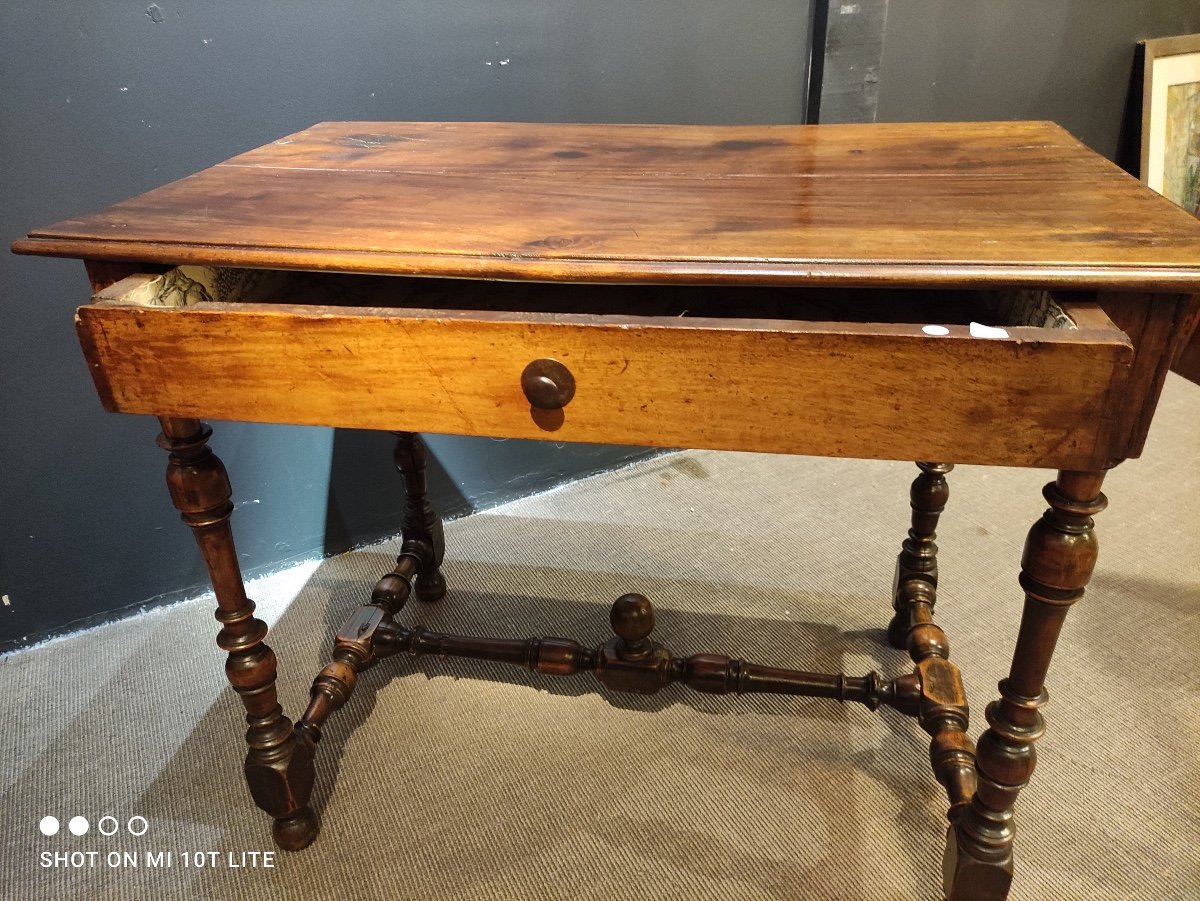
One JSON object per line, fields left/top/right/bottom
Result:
{"left": 0, "top": 377, "right": 1200, "bottom": 901}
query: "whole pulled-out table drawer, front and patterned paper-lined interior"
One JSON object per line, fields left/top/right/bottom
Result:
{"left": 77, "top": 268, "right": 1133, "bottom": 469}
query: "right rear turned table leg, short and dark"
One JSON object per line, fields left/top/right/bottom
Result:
{"left": 888, "top": 463, "right": 954, "bottom": 650}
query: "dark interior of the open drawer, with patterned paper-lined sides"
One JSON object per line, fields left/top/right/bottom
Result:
{"left": 97, "top": 266, "right": 1078, "bottom": 329}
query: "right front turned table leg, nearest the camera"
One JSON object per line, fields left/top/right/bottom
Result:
{"left": 943, "top": 471, "right": 1108, "bottom": 901}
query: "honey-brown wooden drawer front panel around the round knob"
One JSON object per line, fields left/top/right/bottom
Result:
{"left": 77, "top": 293, "right": 1133, "bottom": 469}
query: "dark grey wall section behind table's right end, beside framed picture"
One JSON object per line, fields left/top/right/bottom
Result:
{"left": 873, "top": 0, "right": 1200, "bottom": 162}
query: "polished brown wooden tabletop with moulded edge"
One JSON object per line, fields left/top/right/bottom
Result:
{"left": 13, "top": 122, "right": 1200, "bottom": 292}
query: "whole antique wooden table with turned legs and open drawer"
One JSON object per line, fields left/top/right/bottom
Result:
{"left": 14, "top": 122, "right": 1200, "bottom": 900}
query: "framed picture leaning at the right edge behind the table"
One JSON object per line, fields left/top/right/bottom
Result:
{"left": 1141, "top": 35, "right": 1200, "bottom": 216}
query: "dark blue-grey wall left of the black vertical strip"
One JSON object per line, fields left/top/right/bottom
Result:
{"left": 0, "top": 0, "right": 809, "bottom": 647}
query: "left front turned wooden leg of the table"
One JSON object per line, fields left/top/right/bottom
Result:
{"left": 158, "top": 418, "right": 319, "bottom": 851}
